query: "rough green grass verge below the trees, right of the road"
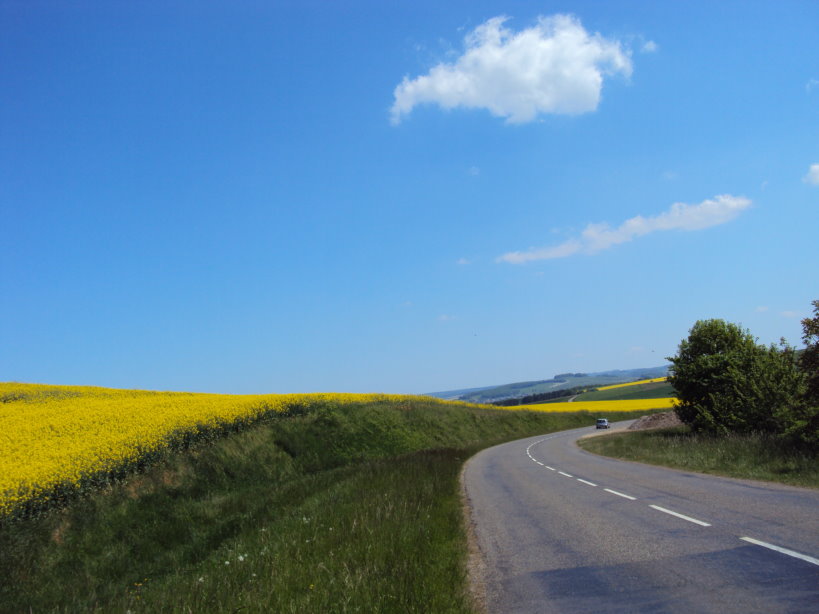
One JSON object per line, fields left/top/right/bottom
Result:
{"left": 579, "top": 427, "right": 819, "bottom": 488}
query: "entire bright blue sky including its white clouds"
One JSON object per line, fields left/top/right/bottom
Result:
{"left": 0, "top": 0, "right": 819, "bottom": 393}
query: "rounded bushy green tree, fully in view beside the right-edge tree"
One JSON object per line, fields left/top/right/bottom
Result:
{"left": 668, "top": 319, "right": 804, "bottom": 434}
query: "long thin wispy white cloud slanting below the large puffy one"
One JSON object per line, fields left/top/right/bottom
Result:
{"left": 497, "top": 194, "right": 751, "bottom": 264}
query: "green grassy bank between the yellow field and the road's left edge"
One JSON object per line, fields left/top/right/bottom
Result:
{"left": 0, "top": 398, "right": 652, "bottom": 612}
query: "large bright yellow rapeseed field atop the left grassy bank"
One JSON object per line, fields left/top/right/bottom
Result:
{"left": 0, "top": 383, "right": 452, "bottom": 516}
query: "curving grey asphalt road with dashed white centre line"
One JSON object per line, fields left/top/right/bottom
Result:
{"left": 463, "top": 423, "right": 819, "bottom": 614}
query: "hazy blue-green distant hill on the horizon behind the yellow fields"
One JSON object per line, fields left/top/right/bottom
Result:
{"left": 427, "top": 365, "right": 668, "bottom": 403}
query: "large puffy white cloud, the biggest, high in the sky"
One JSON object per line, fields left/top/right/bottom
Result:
{"left": 391, "top": 15, "right": 632, "bottom": 124}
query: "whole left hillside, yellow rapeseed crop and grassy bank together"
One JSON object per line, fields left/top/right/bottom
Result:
{"left": 0, "top": 383, "right": 668, "bottom": 614}
